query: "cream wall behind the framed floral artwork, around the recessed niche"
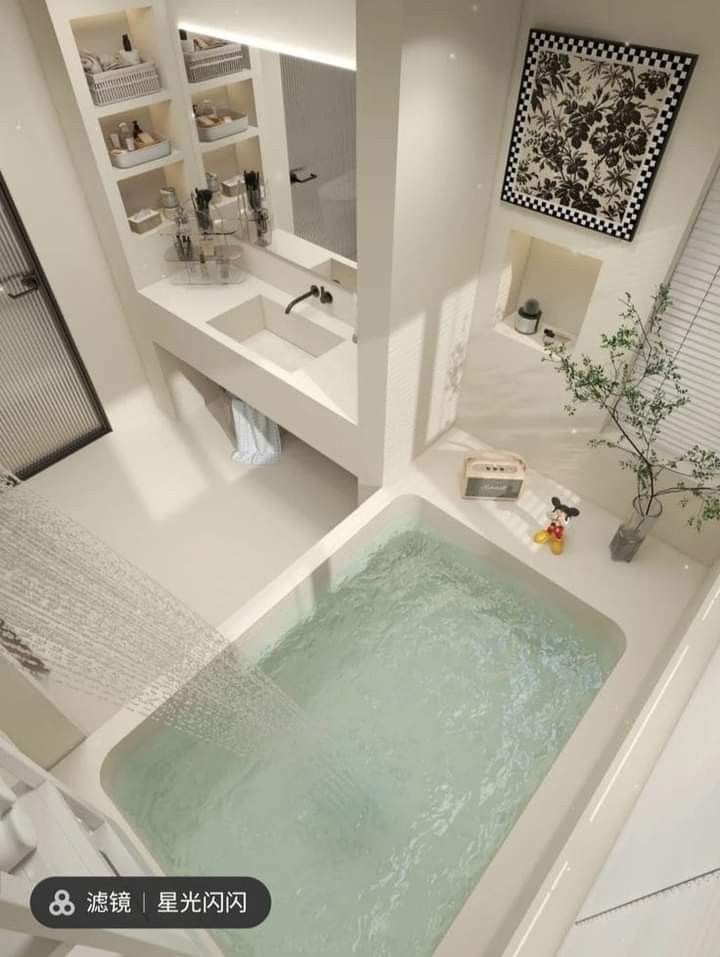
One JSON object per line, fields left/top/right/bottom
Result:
{"left": 459, "top": 0, "right": 720, "bottom": 560}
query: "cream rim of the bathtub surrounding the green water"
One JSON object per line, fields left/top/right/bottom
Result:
{"left": 54, "top": 433, "right": 702, "bottom": 957}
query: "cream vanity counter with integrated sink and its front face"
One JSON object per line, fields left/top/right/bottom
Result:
{"left": 139, "top": 275, "right": 358, "bottom": 471}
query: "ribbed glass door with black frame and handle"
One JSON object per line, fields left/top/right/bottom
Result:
{"left": 0, "top": 176, "right": 110, "bottom": 478}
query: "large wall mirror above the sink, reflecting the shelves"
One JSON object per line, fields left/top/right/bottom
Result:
{"left": 179, "top": 24, "right": 357, "bottom": 293}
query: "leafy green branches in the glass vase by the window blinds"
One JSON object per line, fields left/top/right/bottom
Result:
{"left": 545, "top": 286, "right": 720, "bottom": 530}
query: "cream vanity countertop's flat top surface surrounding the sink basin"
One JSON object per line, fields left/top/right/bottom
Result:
{"left": 140, "top": 275, "right": 357, "bottom": 423}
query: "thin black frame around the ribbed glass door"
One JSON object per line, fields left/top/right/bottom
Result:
{"left": 0, "top": 172, "right": 112, "bottom": 479}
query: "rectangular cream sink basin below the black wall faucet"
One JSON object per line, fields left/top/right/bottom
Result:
{"left": 208, "top": 296, "right": 344, "bottom": 372}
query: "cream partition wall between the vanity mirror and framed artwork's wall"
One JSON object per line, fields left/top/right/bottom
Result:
{"left": 358, "top": 0, "right": 521, "bottom": 484}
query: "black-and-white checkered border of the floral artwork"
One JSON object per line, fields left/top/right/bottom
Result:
{"left": 500, "top": 29, "right": 697, "bottom": 242}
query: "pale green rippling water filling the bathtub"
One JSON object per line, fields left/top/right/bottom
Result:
{"left": 103, "top": 528, "right": 620, "bottom": 957}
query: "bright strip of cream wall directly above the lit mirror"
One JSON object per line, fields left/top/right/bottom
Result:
{"left": 169, "top": 0, "right": 355, "bottom": 65}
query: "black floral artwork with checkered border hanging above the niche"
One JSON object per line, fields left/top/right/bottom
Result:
{"left": 501, "top": 30, "right": 697, "bottom": 242}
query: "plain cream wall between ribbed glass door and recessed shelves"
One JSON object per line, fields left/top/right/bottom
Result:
{"left": 0, "top": 0, "right": 146, "bottom": 423}
